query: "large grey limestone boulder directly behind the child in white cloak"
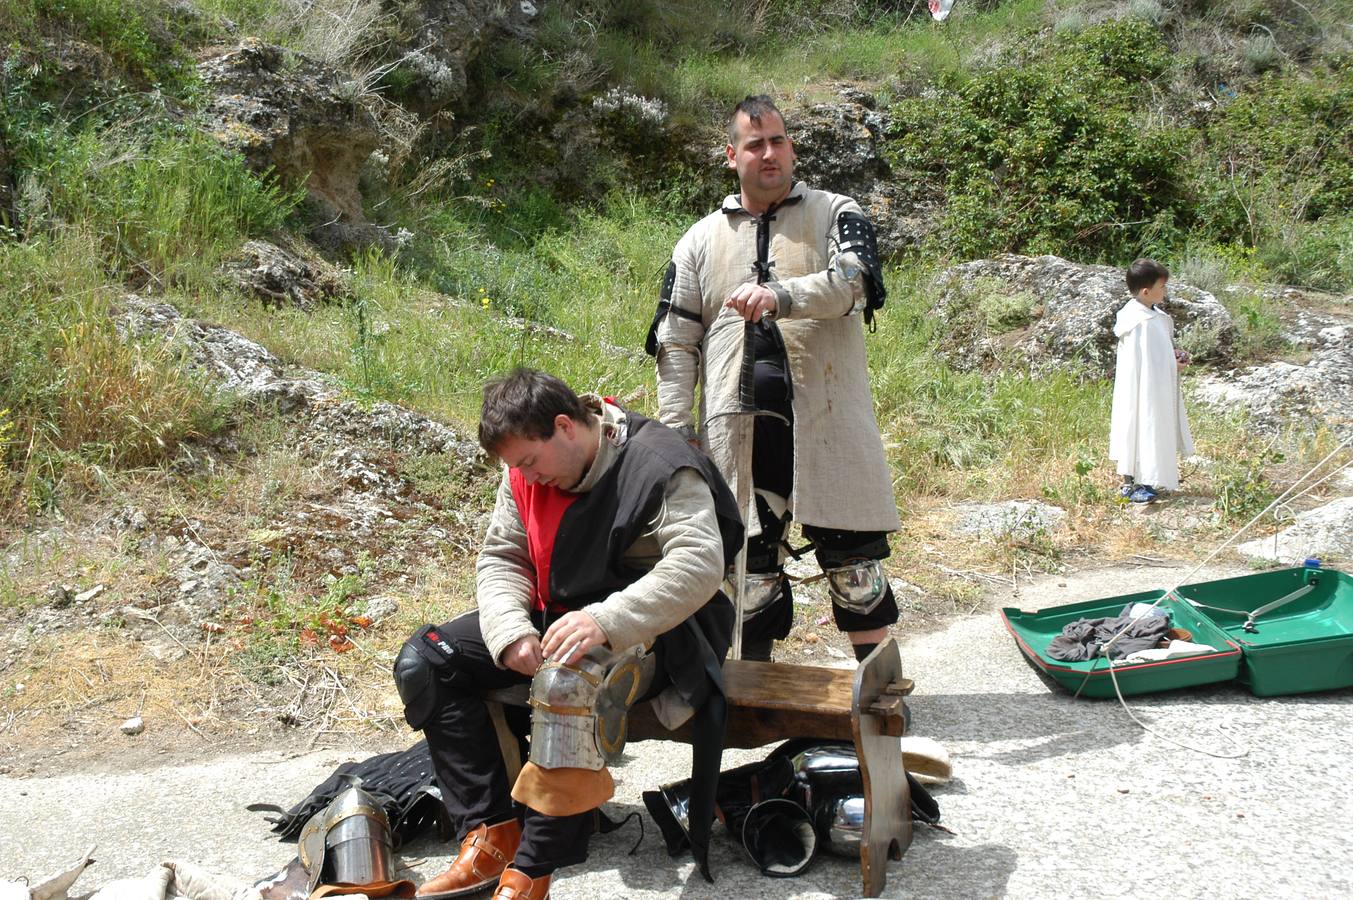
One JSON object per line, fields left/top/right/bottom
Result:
{"left": 934, "top": 254, "right": 1235, "bottom": 375}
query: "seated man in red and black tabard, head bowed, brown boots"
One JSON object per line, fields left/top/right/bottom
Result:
{"left": 395, "top": 369, "right": 743, "bottom": 900}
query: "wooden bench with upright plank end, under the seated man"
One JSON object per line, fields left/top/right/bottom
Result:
{"left": 484, "top": 637, "right": 912, "bottom": 897}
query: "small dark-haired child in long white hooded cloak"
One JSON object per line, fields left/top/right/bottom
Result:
{"left": 1108, "top": 260, "right": 1193, "bottom": 503}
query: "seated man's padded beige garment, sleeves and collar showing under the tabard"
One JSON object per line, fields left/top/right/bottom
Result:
{"left": 475, "top": 395, "right": 724, "bottom": 667}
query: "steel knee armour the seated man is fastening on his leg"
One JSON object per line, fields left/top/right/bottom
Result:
{"left": 530, "top": 646, "right": 658, "bottom": 771}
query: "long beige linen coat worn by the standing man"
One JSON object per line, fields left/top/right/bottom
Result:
{"left": 658, "top": 183, "right": 901, "bottom": 532}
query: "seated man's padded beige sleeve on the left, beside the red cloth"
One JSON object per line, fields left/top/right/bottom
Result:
{"left": 475, "top": 468, "right": 536, "bottom": 667}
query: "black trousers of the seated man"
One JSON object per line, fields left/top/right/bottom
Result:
{"left": 411, "top": 612, "right": 670, "bottom": 877}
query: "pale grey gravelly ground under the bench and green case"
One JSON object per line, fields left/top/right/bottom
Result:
{"left": 0, "top": 564, "right": 1353, "bottom": 900}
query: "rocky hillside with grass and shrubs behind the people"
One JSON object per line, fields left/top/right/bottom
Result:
{"left": 0, "top": 0, "right": 1353, "bottom": 747}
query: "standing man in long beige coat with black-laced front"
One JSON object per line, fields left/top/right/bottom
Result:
{"left": 645, "top": 96, "right": 901, "bottom": 660}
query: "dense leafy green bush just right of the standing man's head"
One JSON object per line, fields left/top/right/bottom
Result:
{"left": 893, "top": 19, "right": 1189, "bottom": 258}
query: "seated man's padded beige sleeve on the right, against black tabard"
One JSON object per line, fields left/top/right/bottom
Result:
{"left": 583, "top": 468, "right": 724, "bottom": 650}
